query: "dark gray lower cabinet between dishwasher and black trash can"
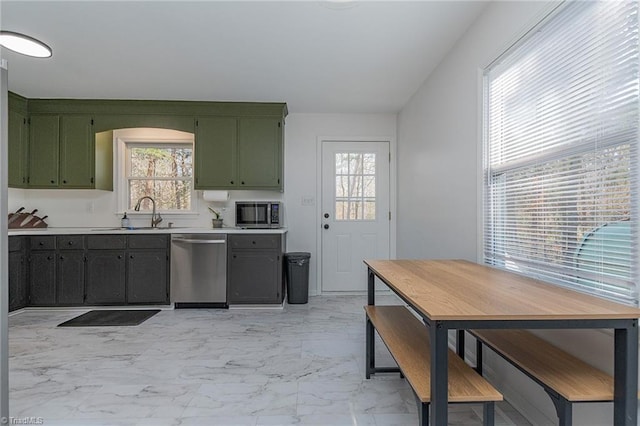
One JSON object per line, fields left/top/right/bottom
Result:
{"left": 227, "top": 234, "right": 284, "bottom": 304}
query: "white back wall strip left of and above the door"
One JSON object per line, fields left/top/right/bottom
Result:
{"left": 284, "top": 114, "right": 396, "bottom": 294}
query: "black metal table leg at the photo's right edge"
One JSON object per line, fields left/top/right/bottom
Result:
{"left": 613, "top": 320, "right": 638, "bottom": 426}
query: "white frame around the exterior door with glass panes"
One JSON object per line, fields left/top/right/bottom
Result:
{"left": 314, "top": 136, "right": 398, "bottom": 295}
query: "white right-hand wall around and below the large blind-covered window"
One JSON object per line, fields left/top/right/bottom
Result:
{"left": 397, "top": 2, "right": 636, "bottom": 426}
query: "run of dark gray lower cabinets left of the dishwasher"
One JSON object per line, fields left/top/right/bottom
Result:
{"left": 9, "top": 234, "right": 170, "bottom": 311}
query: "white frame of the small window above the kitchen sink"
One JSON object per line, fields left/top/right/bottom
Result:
{"left": 114, "top": 137, "right": 198, "bottom": 218}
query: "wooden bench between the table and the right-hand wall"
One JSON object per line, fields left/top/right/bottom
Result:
{"left": 469, "top": 330, "right": 613, "bottom": 426}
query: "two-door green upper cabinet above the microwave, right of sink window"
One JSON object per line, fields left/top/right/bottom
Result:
{"left": 194, "top": 117, "right": 283, "bottom": 191}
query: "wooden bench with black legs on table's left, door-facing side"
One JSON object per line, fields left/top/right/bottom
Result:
{"left": 364, "top": 305, "right": 502, "bottom": 426}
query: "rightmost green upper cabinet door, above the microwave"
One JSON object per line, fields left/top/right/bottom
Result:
{"left": 238, "top": 118, "right": 282, "bottom": 190}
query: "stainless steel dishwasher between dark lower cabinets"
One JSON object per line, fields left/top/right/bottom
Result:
{"left": 171, "top": 234, "right": 229, "bottom": 308}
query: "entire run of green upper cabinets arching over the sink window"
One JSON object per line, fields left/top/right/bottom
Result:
{"left": 8, "top": 93, "right": 287, "bottom": 191}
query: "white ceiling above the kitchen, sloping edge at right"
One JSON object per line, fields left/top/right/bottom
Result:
{"left": 0, "top": 0, "right": 486, "bottom": 113}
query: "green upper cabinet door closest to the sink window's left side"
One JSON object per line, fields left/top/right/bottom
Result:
{"left": 59, "top": 115, "right": 95, "bottom": 189}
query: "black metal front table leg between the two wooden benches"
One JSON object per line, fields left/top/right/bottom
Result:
{"left": 427, "top": 321, "right": 449, "bottom": 426}
